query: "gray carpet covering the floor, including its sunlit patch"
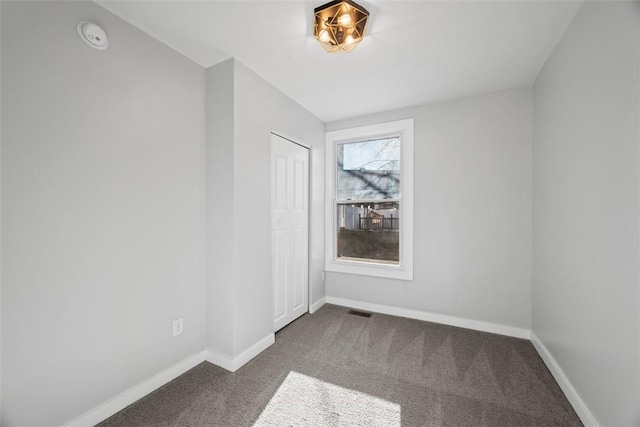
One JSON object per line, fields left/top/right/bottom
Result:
{"left": 100, "top": 305, "right": 582, "bottom": 427}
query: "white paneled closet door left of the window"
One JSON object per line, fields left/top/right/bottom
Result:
{"left": 271, "top": 134, "right": 309, "bottom": 331}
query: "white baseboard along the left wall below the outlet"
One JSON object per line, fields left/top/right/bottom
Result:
{"left": 65, "top": 351, "right": 207, "bottom": 427}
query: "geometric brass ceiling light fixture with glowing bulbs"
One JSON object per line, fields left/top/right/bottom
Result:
{"left": 313, "top": 0, "right": 369, "bottom": 53}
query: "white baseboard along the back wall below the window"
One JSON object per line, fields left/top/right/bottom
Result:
{"left": 326, "top": 296, "right": 531, "bottom": 340}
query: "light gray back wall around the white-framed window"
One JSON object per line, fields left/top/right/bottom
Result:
{"left": 327, "top": 87, "right": 532, "bottom": 328}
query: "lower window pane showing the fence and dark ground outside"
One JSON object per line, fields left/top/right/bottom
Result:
{"left": 336, "top": 202, "right": 400, "bottom": 265}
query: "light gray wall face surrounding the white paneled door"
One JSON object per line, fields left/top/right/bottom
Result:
{"left": 234, "top": 61, "right": 325, "bottom": 351}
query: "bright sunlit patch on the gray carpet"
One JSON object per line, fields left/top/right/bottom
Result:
{"left": 254, "top": 371, "right": 401, "bottom": 427}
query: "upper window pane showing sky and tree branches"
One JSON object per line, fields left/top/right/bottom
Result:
{"left": 336, "top": 137, "right": 400, "bottom": 200}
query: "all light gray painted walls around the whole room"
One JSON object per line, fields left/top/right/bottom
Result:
{"left": 0, "top": 2, "right": 640, "bottom": 426}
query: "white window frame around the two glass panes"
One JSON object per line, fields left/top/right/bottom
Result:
{"left": 325, "top": 119, "right": 413, "bottom": 280}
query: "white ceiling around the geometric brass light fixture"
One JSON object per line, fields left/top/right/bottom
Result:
{"left": 96, "top": 0, "right": 582, "bottom": 122}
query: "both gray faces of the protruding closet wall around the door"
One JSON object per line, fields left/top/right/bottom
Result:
{"left": 206, "top": 59, "right": 325, "bottom": 357}
